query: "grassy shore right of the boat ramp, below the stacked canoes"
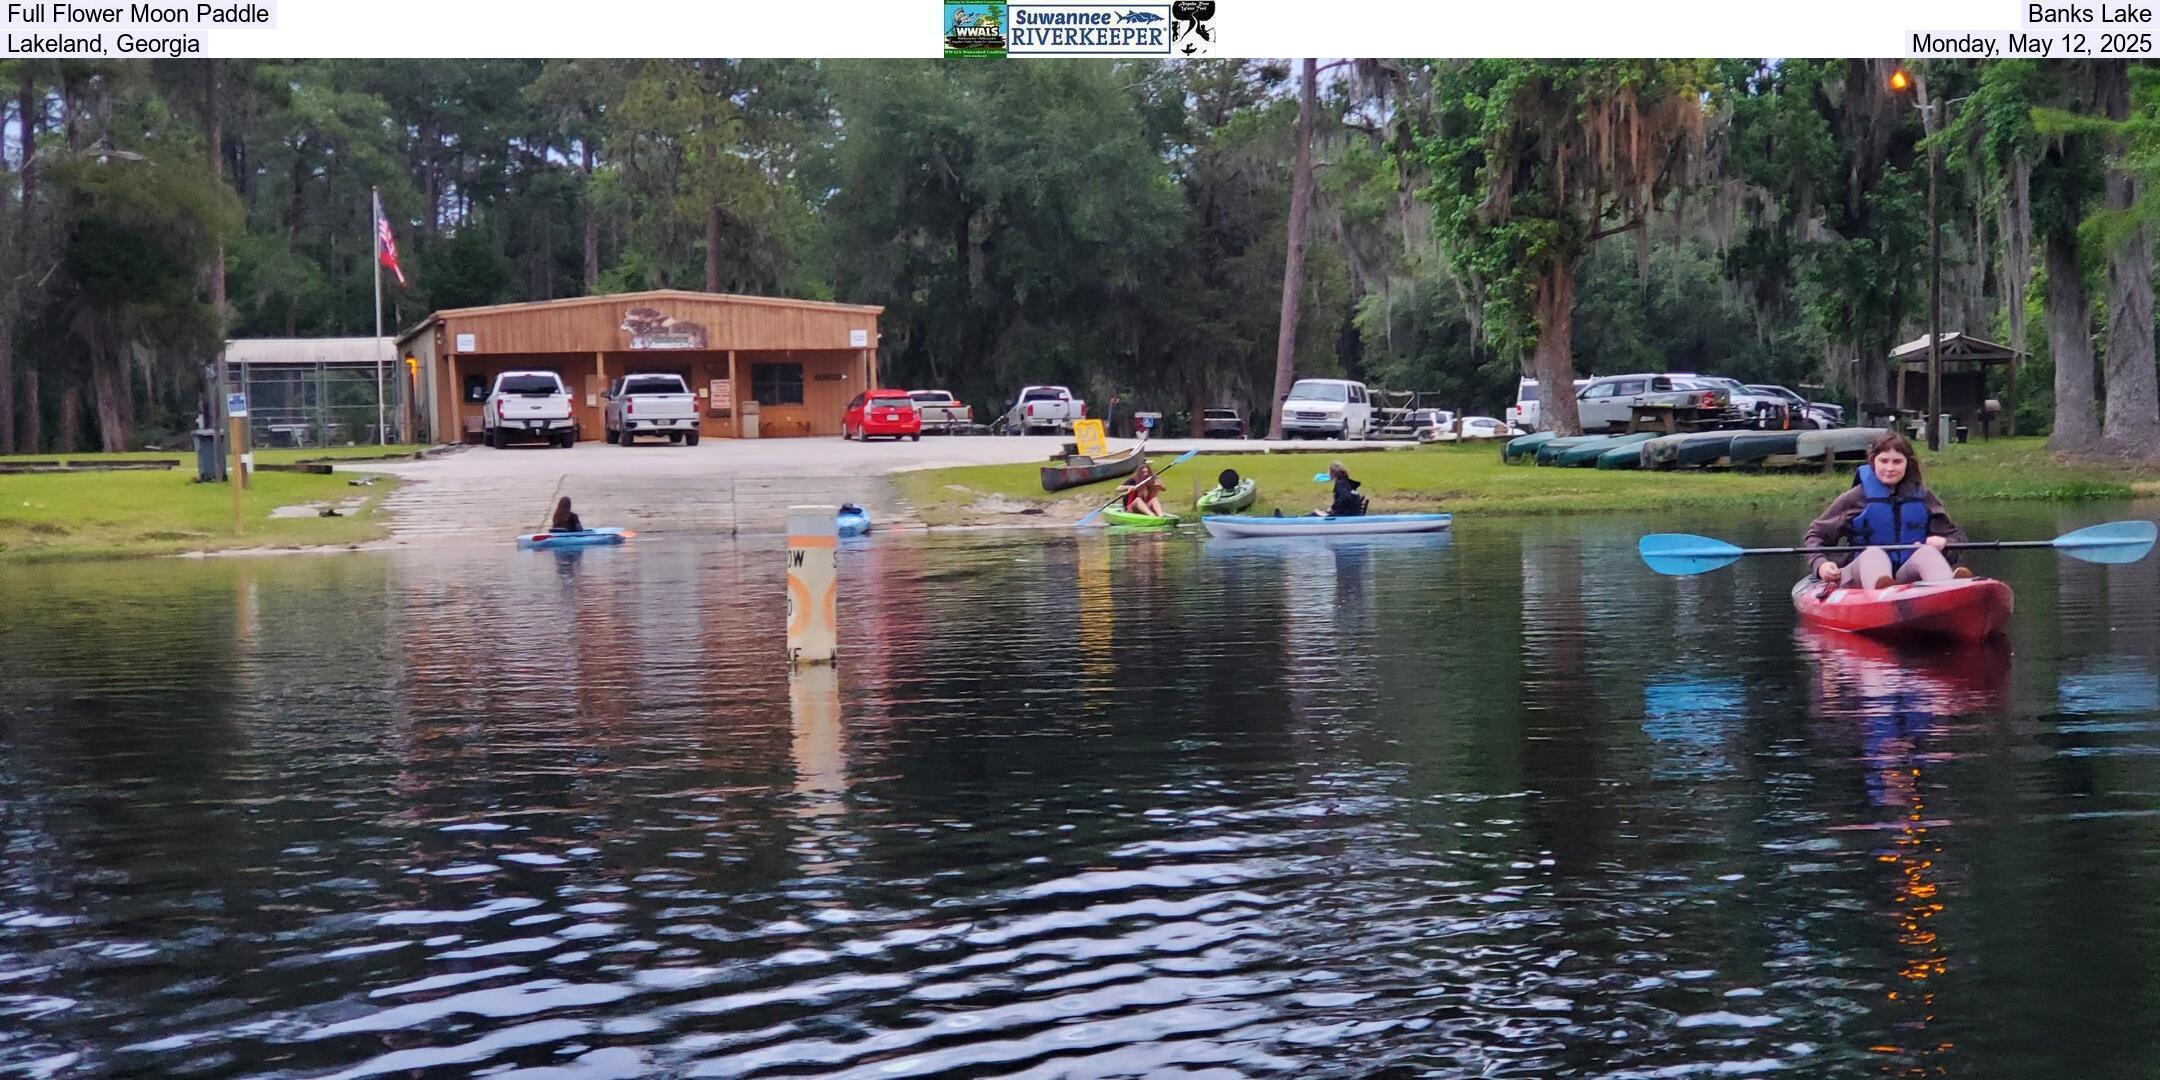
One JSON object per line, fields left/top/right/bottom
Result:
{"left": 894, "top": 438, "right": 2160, "bottom": 525}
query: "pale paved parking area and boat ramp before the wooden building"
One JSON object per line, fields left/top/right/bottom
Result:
{"left": 339, "top": 436, "right": 1389, "bottom": 546}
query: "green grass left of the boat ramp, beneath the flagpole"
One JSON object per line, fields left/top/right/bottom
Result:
{"left": 0, "top": 468, "right": 395, "bottom": 562}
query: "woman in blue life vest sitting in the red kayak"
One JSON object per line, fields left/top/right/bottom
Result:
{"left": 1804, "top": 434, "right": 1972, "bottom": 590}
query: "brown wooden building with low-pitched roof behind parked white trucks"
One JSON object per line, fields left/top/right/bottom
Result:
{"left": 397, "top": 289, "right": 883, "bottom": 443}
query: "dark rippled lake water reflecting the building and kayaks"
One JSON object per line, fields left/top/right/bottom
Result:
{"left": 0, "top": 508, "right": 2160, "bottom": 1078}
